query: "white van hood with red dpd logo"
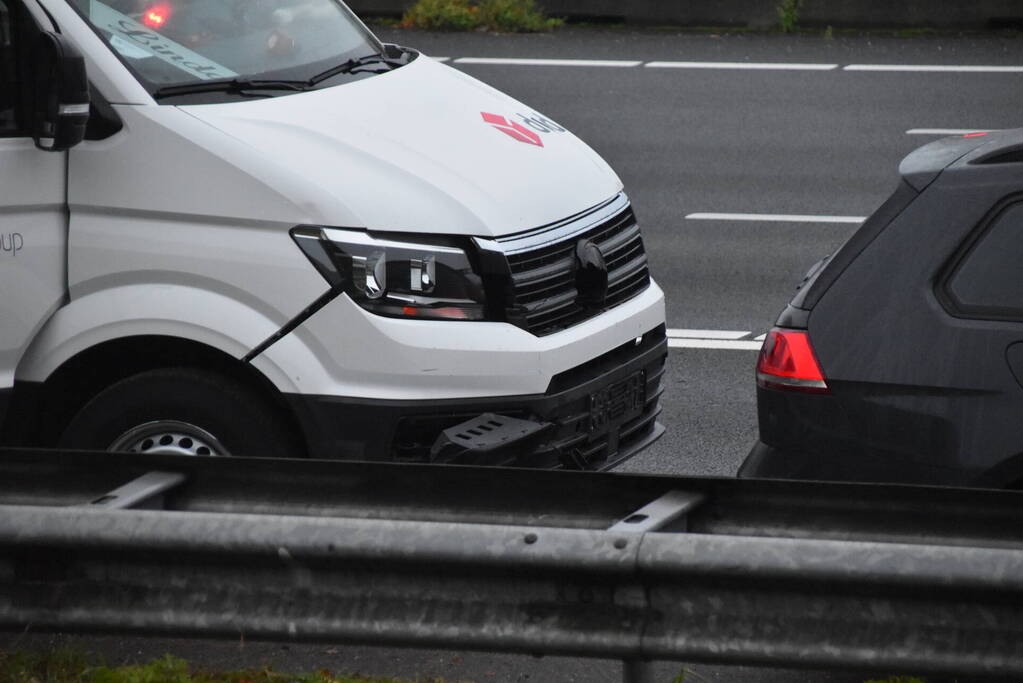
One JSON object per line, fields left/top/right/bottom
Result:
{"left": 179, "top": 55, "right": 622, "bottom": 237}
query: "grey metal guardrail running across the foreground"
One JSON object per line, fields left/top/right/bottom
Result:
{"left": 0, "top": 451, "right": 1023, "bottom": 681}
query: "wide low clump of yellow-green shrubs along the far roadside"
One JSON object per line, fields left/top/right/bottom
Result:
{"left": 401, "top": 0, "right": 564, "bottom": 33}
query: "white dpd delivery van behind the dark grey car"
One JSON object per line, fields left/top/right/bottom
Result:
{"left": 0, "top": 0, "right": 666, "bottom": 468}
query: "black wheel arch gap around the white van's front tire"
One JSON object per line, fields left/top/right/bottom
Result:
{"left": 2, "top": 335, "right": 306, "bottom": 452}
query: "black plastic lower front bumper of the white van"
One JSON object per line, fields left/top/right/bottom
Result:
{"left": 286, "top": 325, "right": 667, "bottom": 469}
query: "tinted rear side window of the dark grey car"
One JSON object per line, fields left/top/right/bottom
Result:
{"left": 947, "top": 202, "right": 1023, "bottom": 319}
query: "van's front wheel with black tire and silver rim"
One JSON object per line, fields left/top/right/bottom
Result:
{"left": 59, "top": 368, "right": 304, "bottom": 457}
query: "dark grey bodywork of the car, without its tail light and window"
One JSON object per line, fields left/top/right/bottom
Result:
{"left": 743, "top": 131, "right": 1023, "bottom": 486}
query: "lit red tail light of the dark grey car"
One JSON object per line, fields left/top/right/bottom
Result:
{"left": 757, "top": 328, "right": 831, "bottom": 394}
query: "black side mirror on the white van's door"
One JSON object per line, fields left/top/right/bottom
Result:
{"left": 32, "top": 32, "right": 89, "bottom": 151}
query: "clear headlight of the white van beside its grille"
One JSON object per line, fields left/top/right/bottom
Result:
{"left": 292, "top": 227, "right": 486, "bottom": 320}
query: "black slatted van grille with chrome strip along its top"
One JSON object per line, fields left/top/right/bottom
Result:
{"left": 484, "top": 194, "right": 650, "bottom": 335}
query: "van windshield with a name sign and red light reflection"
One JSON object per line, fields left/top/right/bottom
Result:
{"left": 71, "top": 0, "right": 383, "bottom": 92}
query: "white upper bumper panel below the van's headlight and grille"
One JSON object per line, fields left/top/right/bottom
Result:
{"left": 253, "top": 282, "right": 664, "bottom": 400}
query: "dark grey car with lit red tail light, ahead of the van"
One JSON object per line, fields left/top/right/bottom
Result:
{"left": 740, "top": 129, "right": 1023, "bottom": 487}
